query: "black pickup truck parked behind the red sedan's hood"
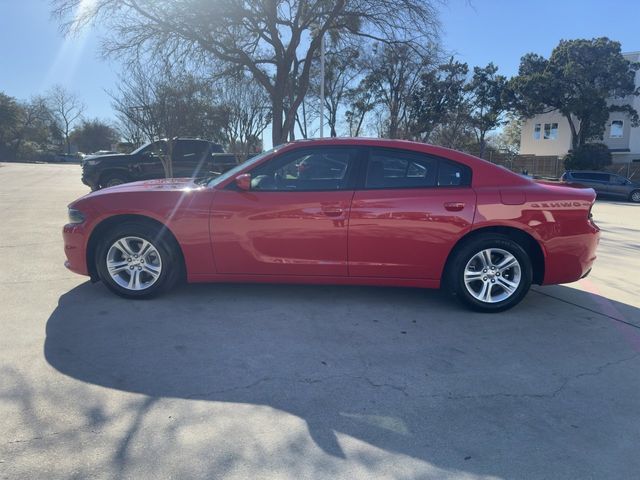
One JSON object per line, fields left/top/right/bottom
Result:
{"left": 82, "top": 138, "right": 237, "bottom": 190}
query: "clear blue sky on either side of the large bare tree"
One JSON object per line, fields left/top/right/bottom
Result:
{"left": 0, "top": 0, "right": 640, "bottom": 144}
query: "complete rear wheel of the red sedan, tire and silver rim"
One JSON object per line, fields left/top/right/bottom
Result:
{"left": 448, "top": 234, "right": 533, "bottom": 312}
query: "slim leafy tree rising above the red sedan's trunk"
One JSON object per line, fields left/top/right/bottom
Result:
{"left": 467, "top": 63, "right": 507, "bottom": 158}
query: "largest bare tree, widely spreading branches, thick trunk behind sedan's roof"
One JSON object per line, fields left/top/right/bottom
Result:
{"left": 53, "top": 0, "right": 438, "bottom": 144}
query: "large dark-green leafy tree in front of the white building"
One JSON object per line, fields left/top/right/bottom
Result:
{"left": 506, "top": 37, "right": 639, "bottom": 150}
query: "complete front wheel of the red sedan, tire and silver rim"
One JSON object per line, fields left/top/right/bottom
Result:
{"left": 96, "top": 222, "right": 181, "bottom": 298}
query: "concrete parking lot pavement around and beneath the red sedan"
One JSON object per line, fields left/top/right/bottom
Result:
{"left": 0, "top": 164, "right": 640, "bottom": 479}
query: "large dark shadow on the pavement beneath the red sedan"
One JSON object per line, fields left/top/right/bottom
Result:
{"left": 44, "top": 283, "right": 640, "bottom": 478}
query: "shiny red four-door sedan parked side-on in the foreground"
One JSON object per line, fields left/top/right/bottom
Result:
{"left": 64, "top": 139, "right": 599, "bottom": 312}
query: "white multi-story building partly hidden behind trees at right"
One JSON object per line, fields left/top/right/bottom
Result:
{"left": 520, "top": 52, "right": 640, "bottom": 163}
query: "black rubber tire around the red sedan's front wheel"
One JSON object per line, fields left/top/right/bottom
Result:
{"left": 95, "top": 222, "right": 183, "bottom": 299}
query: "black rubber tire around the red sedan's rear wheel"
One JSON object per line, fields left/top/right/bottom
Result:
{"left": 446, "top": 234, "right": 533, "bottom": 313}
